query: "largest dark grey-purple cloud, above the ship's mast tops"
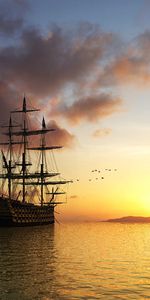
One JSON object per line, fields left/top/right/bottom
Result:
{"left": 0, "top": 25, "right": 113, "bottom": 97}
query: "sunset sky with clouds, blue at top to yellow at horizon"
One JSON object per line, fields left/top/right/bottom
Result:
{"left": 0, "top": 0, "right": 150, "bottom": 221}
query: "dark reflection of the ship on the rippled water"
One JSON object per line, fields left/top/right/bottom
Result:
{"left": 0, "top": 226, "right": 57, "bottom": 300}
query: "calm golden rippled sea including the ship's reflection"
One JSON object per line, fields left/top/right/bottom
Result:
{"left": 0, "top": 223, "right": 150, "bottom": 300}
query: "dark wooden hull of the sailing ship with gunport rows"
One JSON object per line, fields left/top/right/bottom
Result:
{"left": 0, "top": 197, "right": 54, "bottom": 227}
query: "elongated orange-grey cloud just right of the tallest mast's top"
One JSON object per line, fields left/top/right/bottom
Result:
{"left": 51, "top": 93, "right": 122, "bottom": 125}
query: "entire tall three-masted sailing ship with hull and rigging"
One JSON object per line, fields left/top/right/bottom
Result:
{"left": 0, "top": 97, "right": 70, "bottom": 226}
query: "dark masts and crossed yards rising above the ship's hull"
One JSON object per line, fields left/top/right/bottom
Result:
{"left": 0, "top": 97, "right": 72, "bottom": 206}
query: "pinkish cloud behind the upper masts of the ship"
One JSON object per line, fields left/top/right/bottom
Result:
{"left": 0, "top": 85, "right": 76, "bottom": 148}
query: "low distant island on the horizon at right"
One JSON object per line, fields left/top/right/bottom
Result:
{"left": 105, "top": 216, "right": 150, "bottom": 223}
